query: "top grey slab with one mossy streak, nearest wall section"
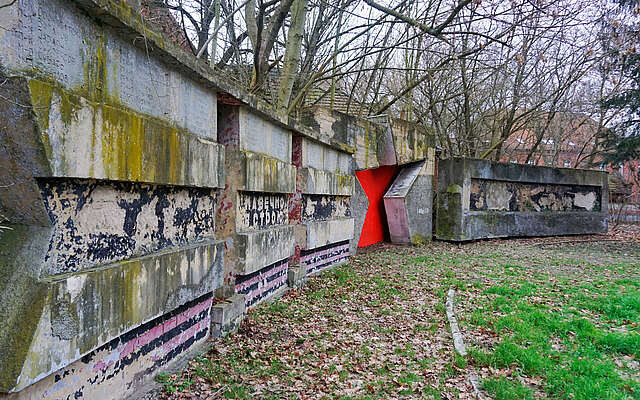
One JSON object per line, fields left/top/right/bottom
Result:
{"left": 0, "top": 0, "right": 216, "bottom": 139}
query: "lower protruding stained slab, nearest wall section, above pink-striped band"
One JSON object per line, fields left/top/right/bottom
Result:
{"left": 2, "top": 240, "right": 224, "bottom": 390}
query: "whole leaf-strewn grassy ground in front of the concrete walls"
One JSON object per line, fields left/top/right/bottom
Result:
{"left": 158, "top": 239, "right": 640, "bottom": 400}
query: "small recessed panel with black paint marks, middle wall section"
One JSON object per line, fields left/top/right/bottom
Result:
{"left": 237, "top": 192, "right": 289, "bottom": 231}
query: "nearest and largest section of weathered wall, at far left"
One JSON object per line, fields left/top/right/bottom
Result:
{"left": 0, "top": 0, "right": 225, "bottom": 398}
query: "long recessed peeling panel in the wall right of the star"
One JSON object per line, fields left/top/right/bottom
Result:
{"left": 469, "top": 179, "right": 602, "bottom": 211}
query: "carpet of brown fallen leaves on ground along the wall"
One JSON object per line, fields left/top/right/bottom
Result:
{"left": 158, "top": 227, "right": 637, "bottom": 400}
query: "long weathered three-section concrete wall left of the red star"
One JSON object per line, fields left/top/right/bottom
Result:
{"left": 0, "top": 0, "right": 436, "bottom": 399}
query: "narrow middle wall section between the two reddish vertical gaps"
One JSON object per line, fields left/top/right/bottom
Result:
{"left": 217, "top": 104, "right": 297, "bottom": 307}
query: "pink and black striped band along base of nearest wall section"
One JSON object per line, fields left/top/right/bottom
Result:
{"left": 25, "top": 293, "right": 213, "bottom": 399}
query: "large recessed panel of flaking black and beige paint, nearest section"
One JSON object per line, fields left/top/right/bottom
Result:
{"left": 39, "top": 179, "right": 216, "bottom": 275}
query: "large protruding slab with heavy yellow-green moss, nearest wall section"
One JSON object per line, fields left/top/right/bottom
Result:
{"left": 29, "top": 79, "right": 224, "bottom": 187}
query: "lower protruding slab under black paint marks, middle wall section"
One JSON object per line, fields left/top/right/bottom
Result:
{"left": 234, "top": 225, "right": 295, "bottom": 275}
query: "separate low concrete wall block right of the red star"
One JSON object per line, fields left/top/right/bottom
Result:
{"left": 435, "top": 159, "right": 609, "bottom": 240}
